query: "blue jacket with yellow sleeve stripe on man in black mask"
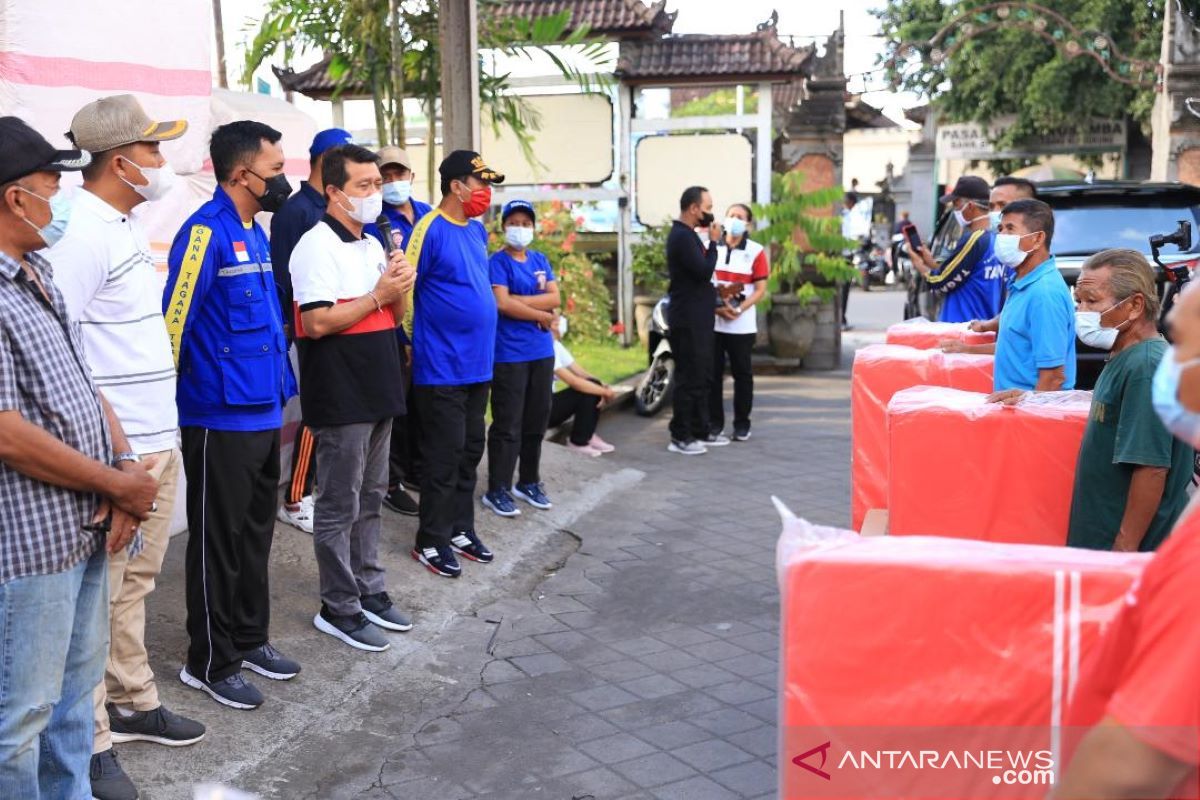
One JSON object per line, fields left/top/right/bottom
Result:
{"left": 162, "top": 186, "right": 296, "bottom": 431}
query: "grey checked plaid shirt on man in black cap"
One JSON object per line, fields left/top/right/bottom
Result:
{"left": 0, "top": 253, "right": 113, "bottom": 583}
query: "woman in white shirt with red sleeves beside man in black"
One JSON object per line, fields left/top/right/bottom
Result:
{"left": 708, "top": 203, "right": 768, "bottom": 441}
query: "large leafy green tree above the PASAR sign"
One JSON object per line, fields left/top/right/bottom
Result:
{"left": 872, "top": 0, "right": 1164, "bottom": 167}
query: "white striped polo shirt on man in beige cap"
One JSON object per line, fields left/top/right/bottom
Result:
{"left": 46, "top": 184, "right": 179, "bottom": 455}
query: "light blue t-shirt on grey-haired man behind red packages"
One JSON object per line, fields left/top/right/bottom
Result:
{"left": 994, "top": 257, "right": 1075, "bottom": 391}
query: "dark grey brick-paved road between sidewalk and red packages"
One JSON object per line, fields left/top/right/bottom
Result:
{"left": 348, "top": 373, "right": 850, "bottom": 800}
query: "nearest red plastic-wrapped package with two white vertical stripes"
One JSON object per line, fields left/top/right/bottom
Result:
{"left": 776, "top": 518, "right": 1151, "bottom": 800}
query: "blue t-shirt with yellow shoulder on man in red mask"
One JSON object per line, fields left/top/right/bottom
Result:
{"left": 406, "top": 211, "right": 496, "bottom": 386}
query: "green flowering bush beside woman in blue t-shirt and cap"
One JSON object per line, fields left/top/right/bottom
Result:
{"left": 488, "top": 200, "right": 612, "bottom": 342}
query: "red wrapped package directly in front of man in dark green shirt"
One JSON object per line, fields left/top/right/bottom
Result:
{"left": 887, "top": 387, "right": 1092, "bottom": 546}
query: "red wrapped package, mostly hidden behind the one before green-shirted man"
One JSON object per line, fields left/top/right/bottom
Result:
{"left": 850, "top": 344, "right": 992, "bottom": 530}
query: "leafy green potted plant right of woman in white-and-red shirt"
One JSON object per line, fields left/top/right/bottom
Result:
{"left": 754, "top": 172, "right": 857, "bottom": 360}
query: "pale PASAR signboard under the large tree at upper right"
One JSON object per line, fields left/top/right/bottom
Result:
{"left": 937, "top": 116, "right": 1126, "bottom": 161}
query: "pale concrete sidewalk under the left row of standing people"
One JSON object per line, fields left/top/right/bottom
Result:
{"left": 118, "top": 443, "right": 642, "bottom": 800}
